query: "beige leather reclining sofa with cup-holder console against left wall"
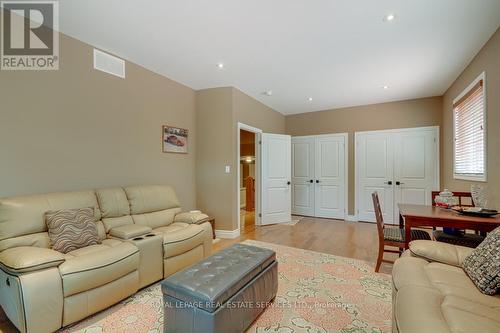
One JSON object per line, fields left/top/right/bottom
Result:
{"left": 0, "top": 186, "right": 212, "bottom": 332}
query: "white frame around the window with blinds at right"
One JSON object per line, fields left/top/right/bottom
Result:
{"left": 452, "top": 72, "right": 488, "bottom": 182}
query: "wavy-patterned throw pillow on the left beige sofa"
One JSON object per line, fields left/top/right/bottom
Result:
{"left": 45, "top": 208, "right": 101, "bottom": 253}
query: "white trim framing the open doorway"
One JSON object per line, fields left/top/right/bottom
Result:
{"left": 236, "top": 122, "right": 262, "bottom": 238}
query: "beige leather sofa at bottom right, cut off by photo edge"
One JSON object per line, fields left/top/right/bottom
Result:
{"left": 392, "top": 240, "right": 500, "bottom": 333}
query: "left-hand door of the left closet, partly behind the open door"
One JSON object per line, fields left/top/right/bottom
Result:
{"left": 292, "top": 137, "right": 315, "bottom": 216}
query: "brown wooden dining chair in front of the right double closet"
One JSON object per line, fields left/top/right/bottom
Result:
{"left": 372, "top": 192, "right": 431, "bottom": 272}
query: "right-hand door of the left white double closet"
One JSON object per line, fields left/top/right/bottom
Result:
{"left": 314, "top": 135, "right": 346, "bottom": 219}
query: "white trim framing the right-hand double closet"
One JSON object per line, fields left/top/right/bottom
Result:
{"left": 352, "top": 126, "right": 441, "bottom": 222}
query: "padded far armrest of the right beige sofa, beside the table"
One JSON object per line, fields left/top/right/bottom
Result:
{"left": 409, "top": 240, "right": 474, "bottom": 267}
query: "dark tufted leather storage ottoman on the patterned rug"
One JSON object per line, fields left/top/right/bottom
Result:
{"left": 161, "top": 244, "right": 278, "bottom": 333}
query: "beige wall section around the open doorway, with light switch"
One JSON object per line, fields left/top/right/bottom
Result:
{"left": 196, "top": 88, "right": 285, "bottom": 231}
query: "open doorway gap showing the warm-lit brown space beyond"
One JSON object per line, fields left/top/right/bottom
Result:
{"left": 238, "top": 129, "right": 257, "bottom": 232}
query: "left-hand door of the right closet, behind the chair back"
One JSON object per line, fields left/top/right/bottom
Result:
{"left": 355, "top": 132, "right": 394, "bottom": 223}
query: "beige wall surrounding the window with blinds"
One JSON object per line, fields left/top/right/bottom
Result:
{"left": 441, "top": 30, "right": 500, "bottom": 209}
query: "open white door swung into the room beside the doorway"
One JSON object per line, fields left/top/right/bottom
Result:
{"left": 261, "top": 133, "right": 292, "bottom": 224}
